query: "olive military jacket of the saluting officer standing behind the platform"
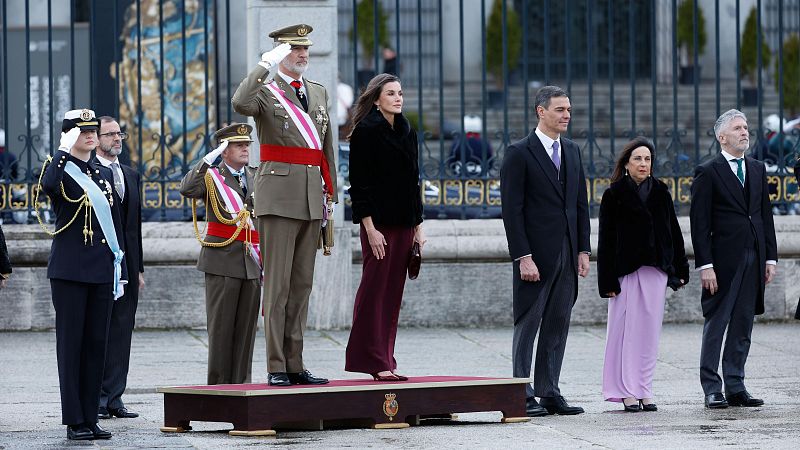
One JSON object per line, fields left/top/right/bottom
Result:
{"left": 181, "top": 160, "right": 261, "bottom": 280}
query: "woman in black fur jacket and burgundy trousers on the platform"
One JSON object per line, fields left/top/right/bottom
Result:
{"left": 345, "top": 74, "right": 425, "bottom": 381}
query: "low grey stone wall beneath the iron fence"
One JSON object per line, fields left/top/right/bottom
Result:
{"left": 0, "top": 217, "right": 800, "bottom": 330}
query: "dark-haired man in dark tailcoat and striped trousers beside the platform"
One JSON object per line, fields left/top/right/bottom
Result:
{"left": 500, "top": 86, "right": 591, "bottom": 416}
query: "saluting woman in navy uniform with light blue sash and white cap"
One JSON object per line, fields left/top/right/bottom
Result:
{"left": 37, "top": 109, "right": 127, "bottom": 440}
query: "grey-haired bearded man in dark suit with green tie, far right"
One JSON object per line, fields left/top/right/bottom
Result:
{"left": 691, "top": 109, "right": 778, "bottom": 408}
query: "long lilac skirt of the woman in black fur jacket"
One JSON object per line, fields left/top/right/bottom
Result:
{"left": 603, "top": 266, "right": 667, "bottom": 402}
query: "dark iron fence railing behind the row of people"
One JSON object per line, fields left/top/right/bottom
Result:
{"left": 0, "top": 0, "right": 800, "bottom": 222}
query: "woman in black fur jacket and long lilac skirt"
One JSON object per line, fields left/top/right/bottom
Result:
{"left": 597, "top": 137, "right": 689, "bottom": 412}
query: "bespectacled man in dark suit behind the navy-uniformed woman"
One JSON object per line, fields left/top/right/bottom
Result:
{"left": 95, "top": 116, "right": 144, "bottom": 419}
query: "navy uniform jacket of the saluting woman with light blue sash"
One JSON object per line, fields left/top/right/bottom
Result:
{"left": 42, "top": 150, "right": 128, "bottom": 284}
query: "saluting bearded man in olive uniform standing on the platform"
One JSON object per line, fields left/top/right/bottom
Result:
{"left": 232, "top": 24, "right": 338, "bottom": 386}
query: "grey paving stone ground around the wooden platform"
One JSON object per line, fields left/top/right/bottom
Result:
{"left": 0, "top": 322, "right": 800, "bottom": 449}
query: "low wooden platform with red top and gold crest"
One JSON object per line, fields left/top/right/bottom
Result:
{"left": 157, "top": 376, "right": 531, "bottom": 436}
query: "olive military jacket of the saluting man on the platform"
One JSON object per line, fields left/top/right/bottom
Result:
{"left": 231, "top": 65, "right": 338, "bottom": 220}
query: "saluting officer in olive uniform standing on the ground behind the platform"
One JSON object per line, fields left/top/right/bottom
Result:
{"left": 181, "top": 123, "right": 261, "bottom": 384}
